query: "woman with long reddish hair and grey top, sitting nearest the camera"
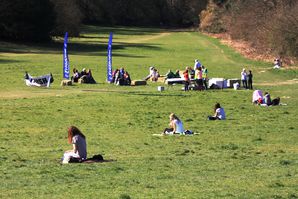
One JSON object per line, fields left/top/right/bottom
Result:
{"left": 62, "top": 126, "right": 87, "bottom": 164}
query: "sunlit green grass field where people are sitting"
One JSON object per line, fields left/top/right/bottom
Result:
{"left": 0, "top": 26, "right": 298, "bottom": 199}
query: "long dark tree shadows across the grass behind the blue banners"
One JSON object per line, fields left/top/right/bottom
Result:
{"left": 0, "top": 26, "right": 165, "bottom": 58}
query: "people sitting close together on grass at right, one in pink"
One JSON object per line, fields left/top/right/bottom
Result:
{"left": 252, "top": 90, "right": 280, "bottom": 106}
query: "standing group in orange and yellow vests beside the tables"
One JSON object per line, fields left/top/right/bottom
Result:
{"left": 183, "top": 65, "right": 208, "bottom": 91}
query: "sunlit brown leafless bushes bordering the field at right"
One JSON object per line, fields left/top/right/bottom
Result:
{"left": 200, "top": 0, "right": 298, "bottom": 58}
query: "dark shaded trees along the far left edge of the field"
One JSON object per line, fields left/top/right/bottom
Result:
{"left": 0, "top": 0, "right": 207, "bottom": 41}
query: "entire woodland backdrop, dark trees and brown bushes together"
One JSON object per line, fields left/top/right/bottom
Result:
{"left": 0, "top": 0, "right": 298, "bottom": 57}
